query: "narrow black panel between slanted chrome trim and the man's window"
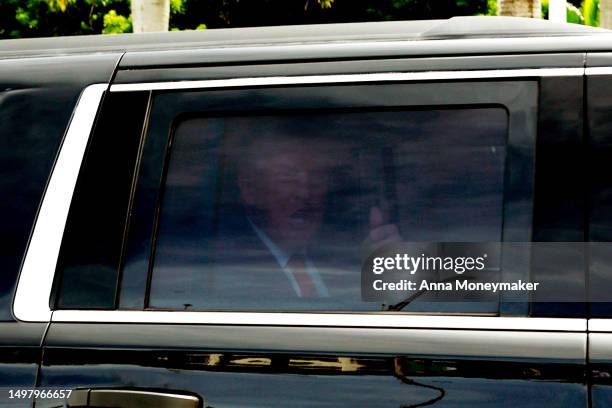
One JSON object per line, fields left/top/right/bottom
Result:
{"left": 54, "top": 92, "right": 149, "bottom": 309}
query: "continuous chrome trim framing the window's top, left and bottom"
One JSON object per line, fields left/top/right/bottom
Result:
{"left": 13, "top": 68, "right": 586, "bottom": 332}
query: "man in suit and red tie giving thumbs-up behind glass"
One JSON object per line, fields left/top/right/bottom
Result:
{"left": 210, "top": 120, "right": 400, "bottom": 301}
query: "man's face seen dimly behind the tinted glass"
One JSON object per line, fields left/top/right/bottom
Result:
{"left": 239, "top": 141, "right": 328, "bottom": 250}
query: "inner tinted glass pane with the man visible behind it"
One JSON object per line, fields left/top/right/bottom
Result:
{"left": 148, "top": 108, "right": 508, "bottom": 311}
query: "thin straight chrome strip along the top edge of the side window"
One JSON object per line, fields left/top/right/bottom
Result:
{"left": 110, "top": 68, "right": 584, "bottom": 92}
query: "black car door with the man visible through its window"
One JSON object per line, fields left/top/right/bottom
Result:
{"left": 15, "top": 51, "right": 587, "bottom": 407}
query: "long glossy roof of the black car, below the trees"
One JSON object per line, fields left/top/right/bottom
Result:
{"left": 0, "top": 17, "right": 610, "bottom": 61}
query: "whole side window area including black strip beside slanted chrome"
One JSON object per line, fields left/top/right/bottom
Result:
{"left": 54, "top": 81, "right": 537, "bottom": 315}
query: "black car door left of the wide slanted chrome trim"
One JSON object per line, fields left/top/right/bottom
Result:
{"left": 0, "top": 52, "right": 120, "bottom": 407}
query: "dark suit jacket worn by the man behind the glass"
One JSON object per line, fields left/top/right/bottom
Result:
{"left": 203, "top": 209, "right": 361, "bottom": 310}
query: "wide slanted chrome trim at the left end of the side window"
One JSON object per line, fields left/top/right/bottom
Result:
{"left": 13, "top": 84, "right": 108, "bottom": 322}
